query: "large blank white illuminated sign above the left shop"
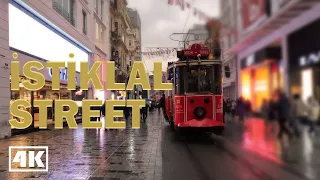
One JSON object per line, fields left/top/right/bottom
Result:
{"left": 9, "top": 4, "right": 89, "bottom": 72}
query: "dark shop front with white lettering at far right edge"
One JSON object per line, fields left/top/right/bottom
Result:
{"left": 288, "top": 18, "right": 320, "bottom": 102}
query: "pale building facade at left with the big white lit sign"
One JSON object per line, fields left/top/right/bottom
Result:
{"left": 0, "top": 0, "right": 116, "bottom": 138}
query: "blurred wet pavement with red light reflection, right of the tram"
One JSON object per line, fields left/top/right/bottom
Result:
{"left": 224, "top": 118, "right": 320, "bottom": 179}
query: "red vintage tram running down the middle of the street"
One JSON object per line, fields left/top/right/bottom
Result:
{"left": 164, "top": 44, "right": 224, "bottom": 134}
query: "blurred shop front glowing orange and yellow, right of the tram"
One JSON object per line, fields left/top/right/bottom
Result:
{"left": 240, "top": 47, "right": 282, "bottom": 111}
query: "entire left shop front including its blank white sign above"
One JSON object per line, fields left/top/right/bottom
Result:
{"left": 9, "top": 1, "right": 91, "bottom": 134}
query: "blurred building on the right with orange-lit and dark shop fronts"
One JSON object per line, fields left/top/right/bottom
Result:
{"left": 226, "top": 0, "right": 320, "bottom": 111}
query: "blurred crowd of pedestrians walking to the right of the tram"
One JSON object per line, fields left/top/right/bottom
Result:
{"left": 223, "top": 90, "right": 320, "bottom": 139}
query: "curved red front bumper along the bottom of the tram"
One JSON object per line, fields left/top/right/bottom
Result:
{"left": 178, "top": 119, "right": 224, "bottom": 128}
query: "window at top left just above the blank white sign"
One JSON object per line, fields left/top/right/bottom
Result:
{"left": 52, "top": 0, "right": 75, "bottom": 26}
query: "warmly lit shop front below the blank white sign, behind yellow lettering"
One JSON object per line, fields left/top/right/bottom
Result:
{"left": 10, "top": 53, "right": 88, "bottom": 133}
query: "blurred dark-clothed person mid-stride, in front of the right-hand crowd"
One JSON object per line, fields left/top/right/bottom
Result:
{"left": 277, "top": 91, "right": 292, "bottom": 139}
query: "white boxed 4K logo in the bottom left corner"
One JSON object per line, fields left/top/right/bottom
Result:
{"left": 9, "top": 146, "right": 48, "bottom": 172}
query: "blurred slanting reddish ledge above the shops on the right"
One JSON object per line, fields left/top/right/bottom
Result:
{"left": 225, "top": 0, "right": 319, "bottom": 54}
